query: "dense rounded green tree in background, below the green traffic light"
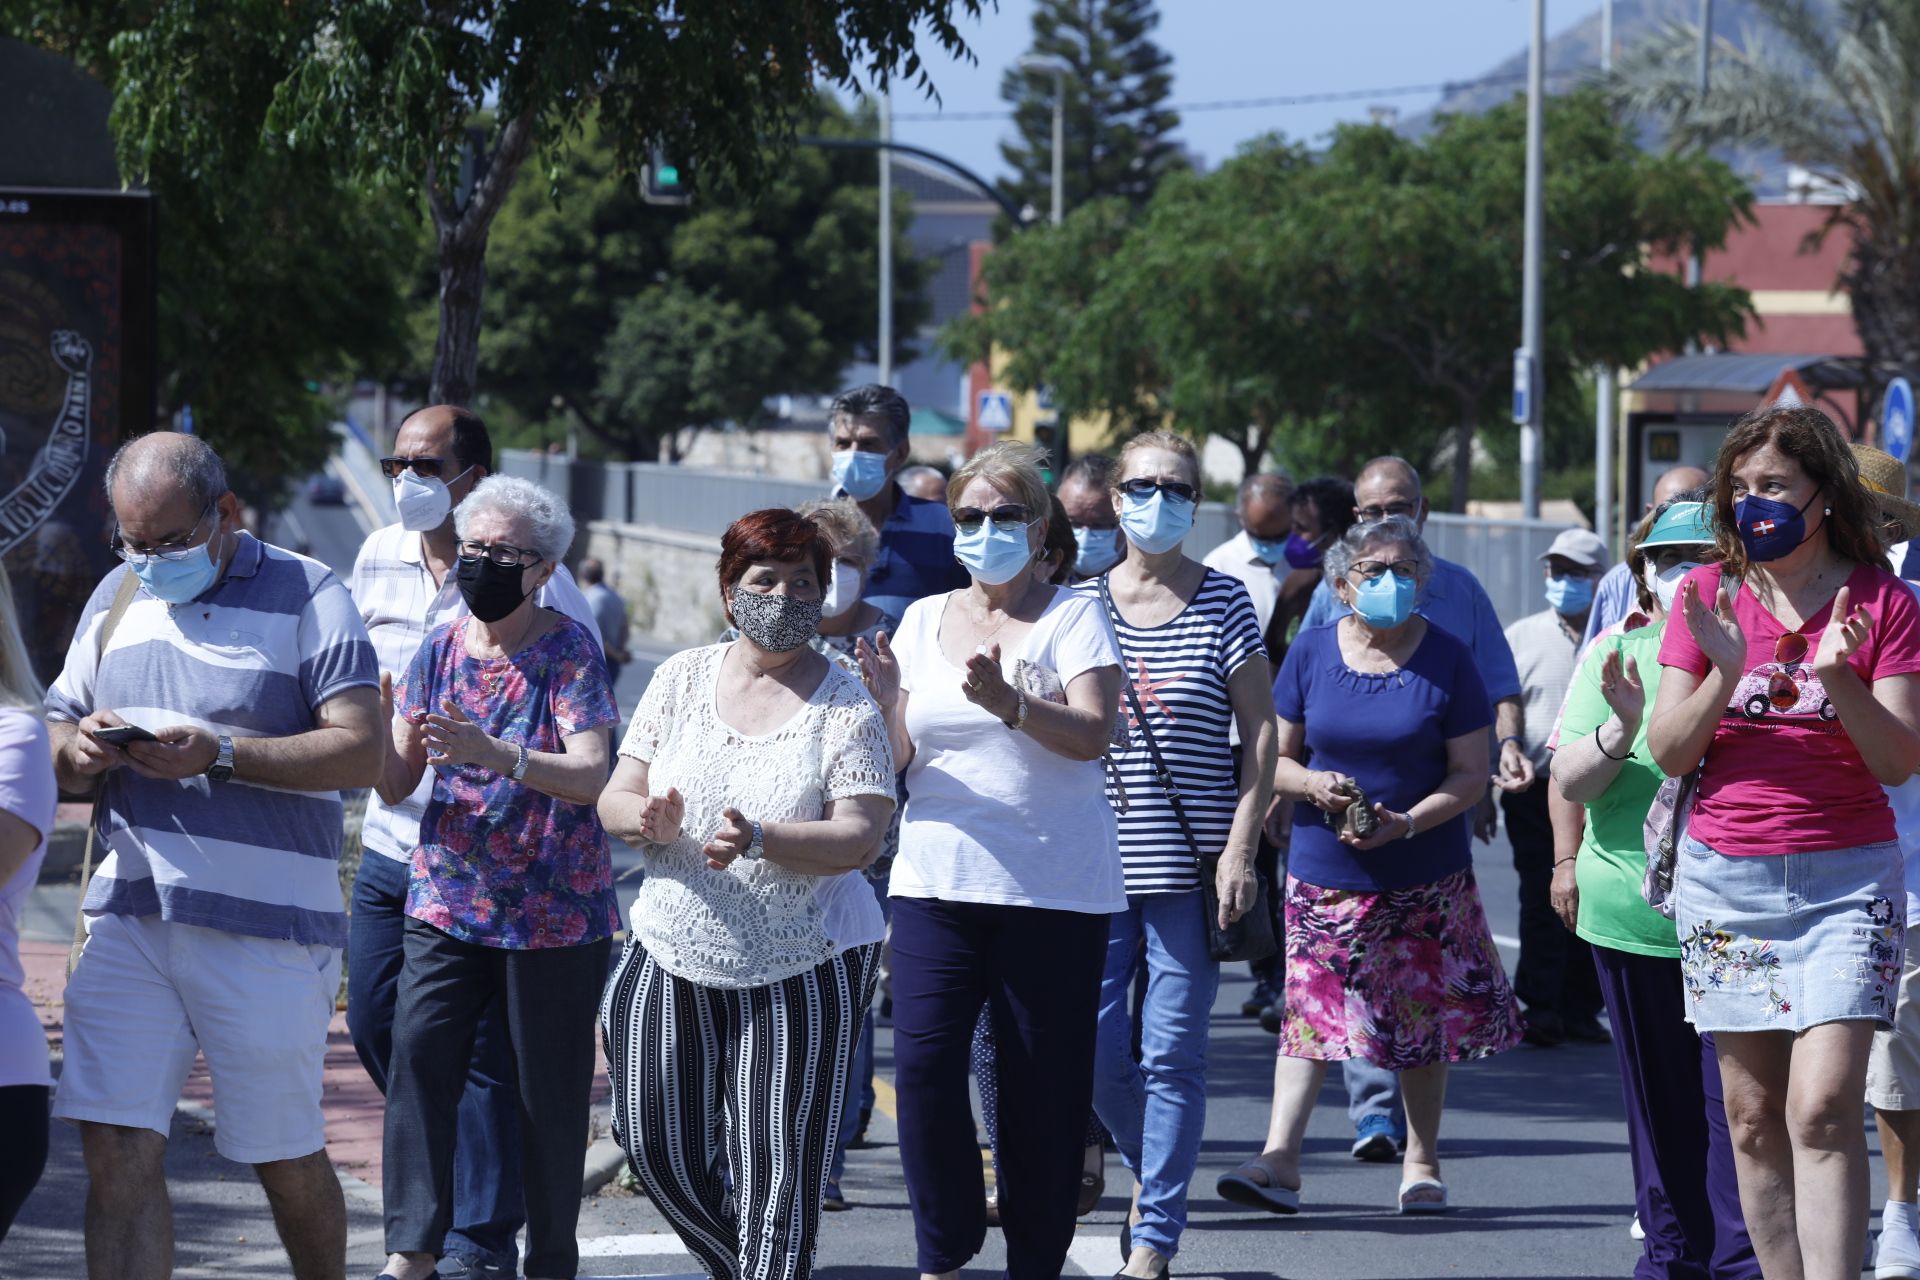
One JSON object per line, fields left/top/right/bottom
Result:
{"left": 480, "top": 96, "right": 927, "bottom": 459}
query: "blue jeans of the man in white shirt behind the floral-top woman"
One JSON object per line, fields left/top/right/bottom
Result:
{"left": 348, "top": 848, "right": 526, "bottom": 1263}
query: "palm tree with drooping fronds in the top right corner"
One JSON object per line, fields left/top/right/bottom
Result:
{"left": 1615, "top": 0, "right": 1920, "bottom": 416}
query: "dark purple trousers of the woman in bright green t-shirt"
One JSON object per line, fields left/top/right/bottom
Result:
{"left": 1594, "top": 944, "right": 1761, "bottom": 1280}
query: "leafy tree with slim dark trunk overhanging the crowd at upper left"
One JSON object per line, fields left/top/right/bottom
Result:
{"left": 84, "top": 0, "right": 981, "bottom": 403}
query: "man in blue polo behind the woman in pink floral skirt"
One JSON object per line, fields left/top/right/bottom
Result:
{"left": 1300, "top": 457, "right": 1534, "bottom": 1161}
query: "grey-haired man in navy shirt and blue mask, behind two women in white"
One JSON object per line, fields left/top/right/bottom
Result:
{"left": 828, "top": 384, "right": 972, "bottom": 618}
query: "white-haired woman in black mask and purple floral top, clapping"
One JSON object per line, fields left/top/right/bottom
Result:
{"left": 380, "top": 476, "right": 618, "bottom": 1280}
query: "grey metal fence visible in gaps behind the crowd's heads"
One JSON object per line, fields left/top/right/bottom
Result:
{"left": 501, "top": 449, "right": 1567, "bottom": 624}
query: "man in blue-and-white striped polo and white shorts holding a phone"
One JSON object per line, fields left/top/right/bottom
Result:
{"left": 46, "top": 432, "right": 382, "bottom": 1280}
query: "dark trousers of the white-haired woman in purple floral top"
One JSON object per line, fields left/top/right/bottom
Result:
{"left": 382, "top": 917, "right": 612, "bottom": 1278}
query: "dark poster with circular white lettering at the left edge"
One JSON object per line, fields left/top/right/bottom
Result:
{"left": 0, "top": 186, "right": 154, "bottom": 679}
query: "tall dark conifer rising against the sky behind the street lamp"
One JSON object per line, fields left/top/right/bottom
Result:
{"left": 998, "top": 0, "right": 1187, "bottom": 232}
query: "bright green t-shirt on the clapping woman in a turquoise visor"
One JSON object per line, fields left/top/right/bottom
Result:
{"left": 1559, "top": 626, "right": 1680, "bottom": 958}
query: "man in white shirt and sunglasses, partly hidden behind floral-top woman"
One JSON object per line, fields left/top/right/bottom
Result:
{"left": 348, "top": 405, "right": 603, "bottom": 1280}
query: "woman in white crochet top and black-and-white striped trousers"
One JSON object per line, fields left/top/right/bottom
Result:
{"left": 599, "top": 510, "right": 893, "bottom": 1280}
